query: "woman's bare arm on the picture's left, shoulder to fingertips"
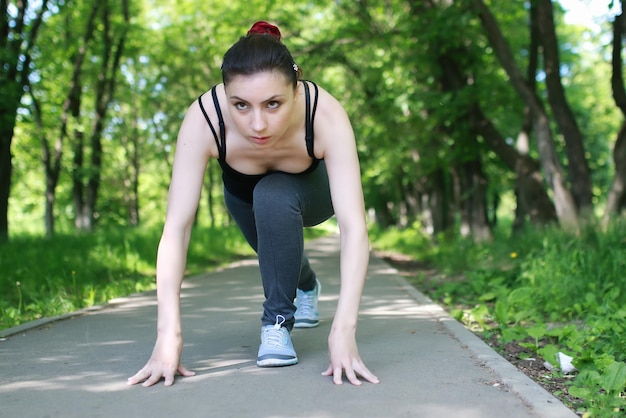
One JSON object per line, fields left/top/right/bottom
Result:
{"left": 128, "top": 102, "right": 212, "bottom": 386}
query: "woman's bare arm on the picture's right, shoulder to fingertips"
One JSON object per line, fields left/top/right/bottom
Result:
{"left": 315, "top": 90, "right": 378, "bottom": 385}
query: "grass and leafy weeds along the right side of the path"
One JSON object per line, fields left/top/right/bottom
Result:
{"left": 371, "top": 220, "right": 626, "bottom": 417}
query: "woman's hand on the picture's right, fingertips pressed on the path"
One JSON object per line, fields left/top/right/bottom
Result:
{"left": 322, "top": 330, "right": 379, "bottom": 386}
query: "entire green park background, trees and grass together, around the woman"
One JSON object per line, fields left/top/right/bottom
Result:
{"left": 0, "top": 0, "right": 626, "bottom": 416}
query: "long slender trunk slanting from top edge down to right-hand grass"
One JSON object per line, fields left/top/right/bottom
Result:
{"left": 472, "top": 0, "right": 578, "bottom": 230}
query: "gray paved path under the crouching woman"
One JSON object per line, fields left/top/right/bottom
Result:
{"left": 0, "top": 237, "right": 576, "bottom": 418}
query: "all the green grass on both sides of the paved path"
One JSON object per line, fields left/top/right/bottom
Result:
{"left": 0, "top": 219, "right": 626, "bottom": 417}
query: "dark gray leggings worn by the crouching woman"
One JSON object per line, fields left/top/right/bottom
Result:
{"left": 224, "top": 161, "right": 334, "bottom": 330}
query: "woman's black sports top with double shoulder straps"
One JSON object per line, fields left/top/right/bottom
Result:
{"left": 198, "top": 81, "right": 320, "bottom": 203}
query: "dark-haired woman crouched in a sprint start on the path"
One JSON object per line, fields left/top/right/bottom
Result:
{"left": 128, "top": 22, "right": 378, "bottom": 386}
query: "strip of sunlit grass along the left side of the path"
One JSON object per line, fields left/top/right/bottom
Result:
{"left": 0, "top": 227, "right": 252, "bottom": 329}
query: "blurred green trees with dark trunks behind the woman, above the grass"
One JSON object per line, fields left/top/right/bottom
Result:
{"left": 0, "top": 0, "right": 626, "bottom": 241}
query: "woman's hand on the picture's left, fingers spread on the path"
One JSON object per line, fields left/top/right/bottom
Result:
{"left": 128, "top": 336, "right": 196, "bottom": 387}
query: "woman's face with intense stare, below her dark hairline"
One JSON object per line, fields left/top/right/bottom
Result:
{"left": 225, "top": 71, "right": 296, "bottom": 147}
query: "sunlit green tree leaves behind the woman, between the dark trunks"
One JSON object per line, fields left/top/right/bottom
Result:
{"left": 3, "top": 0, "right": 620, "bottom": 237}
